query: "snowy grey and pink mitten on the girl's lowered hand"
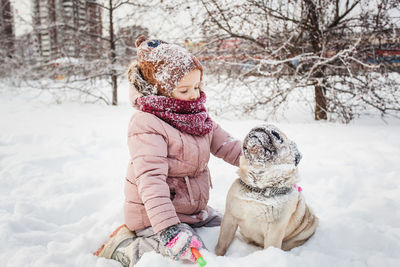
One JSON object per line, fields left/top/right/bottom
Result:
{"left": 159, "top": 223, "right": 203, "bottom": 263}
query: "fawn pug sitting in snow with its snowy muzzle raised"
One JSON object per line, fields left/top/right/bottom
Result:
{"left": 215, "top": 125, "right": 318, "bottom": 256}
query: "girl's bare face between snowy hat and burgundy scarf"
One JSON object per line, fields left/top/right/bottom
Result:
{"left": 171, "top": 69, "right": 201, "bottom": 100}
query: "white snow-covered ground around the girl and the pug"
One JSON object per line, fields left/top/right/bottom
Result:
{"left": 0, "top": 85, "right": 400, "bottom": 267}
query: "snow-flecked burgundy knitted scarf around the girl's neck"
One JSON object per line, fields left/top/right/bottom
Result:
{"left": 136, "top": 91, "right": 213, "bottom": 136}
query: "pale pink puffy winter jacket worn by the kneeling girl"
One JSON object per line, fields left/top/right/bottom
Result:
{"left": 125, "top": 111, "right": 241, "bottom": 232}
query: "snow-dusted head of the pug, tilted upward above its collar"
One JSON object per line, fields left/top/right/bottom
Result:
{"left": 241, "top": 125, "right": 301, "bottom": 186}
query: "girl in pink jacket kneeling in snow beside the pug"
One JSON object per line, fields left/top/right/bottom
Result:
{"left": 95, "top": 36, "right": 241, "bottom": 266}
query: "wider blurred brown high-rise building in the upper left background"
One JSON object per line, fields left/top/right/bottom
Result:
{"left": 32, "top": 0, "right": 102, "bottom": 62}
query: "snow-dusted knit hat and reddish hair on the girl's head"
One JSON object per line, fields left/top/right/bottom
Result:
{"left": 136, "top": 35, "right": 203, "bottom": 96}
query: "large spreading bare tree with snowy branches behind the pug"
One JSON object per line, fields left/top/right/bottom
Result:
{"left": 200, "top": 0, "right": 400, "bottom": 122}
